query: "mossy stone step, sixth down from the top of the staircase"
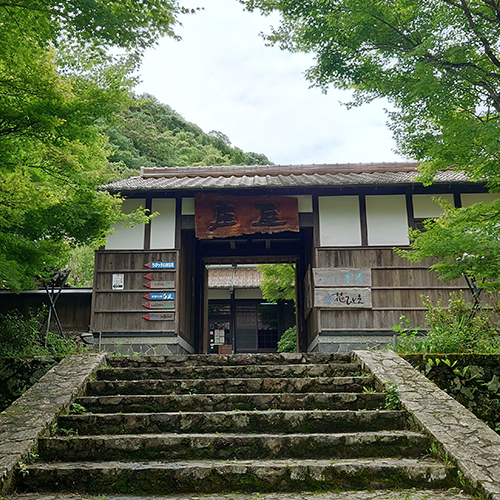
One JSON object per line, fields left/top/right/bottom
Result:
{"left": 38, "top": 431, "right": 430, "bottom": 461}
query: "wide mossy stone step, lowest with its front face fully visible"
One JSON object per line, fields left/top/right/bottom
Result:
{"left": 18, "top": 459, "right": 455, "bottom": 495}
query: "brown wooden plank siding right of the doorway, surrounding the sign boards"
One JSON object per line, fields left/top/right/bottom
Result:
{"left": 308, "top": 247, "right": 472, "bottom": 341}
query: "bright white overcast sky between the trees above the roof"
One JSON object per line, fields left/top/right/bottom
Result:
{"left": 136, "top": 0, "right": 401, "bottom": 164}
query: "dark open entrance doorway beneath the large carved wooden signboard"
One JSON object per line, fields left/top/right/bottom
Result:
{"left": 188, "top": 227, "right": 312, "bottom": 354}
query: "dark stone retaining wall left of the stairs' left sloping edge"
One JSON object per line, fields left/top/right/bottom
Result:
{"left": 0, "top": 356, "right": 61, "bottom": 411}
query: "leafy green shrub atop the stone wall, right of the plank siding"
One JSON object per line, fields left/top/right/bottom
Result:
{"left": 394, "top": 292, "right": 500, "bottom": 353}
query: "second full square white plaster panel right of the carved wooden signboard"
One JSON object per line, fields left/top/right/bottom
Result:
{"left": 366, "top": 194, "right": 409, "bottom": 246}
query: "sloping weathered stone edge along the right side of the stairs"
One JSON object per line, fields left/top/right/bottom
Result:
{"left": 352, "top": 351, "right": 500, "bottom": 500}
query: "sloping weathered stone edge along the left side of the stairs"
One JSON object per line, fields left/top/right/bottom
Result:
{"left": 0, "top": 353, "right": 106, "bottom": 496}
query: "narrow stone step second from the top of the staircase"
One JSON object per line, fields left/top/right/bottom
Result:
{"left": 97, "top": 358, "right": 360, "bottom": 380}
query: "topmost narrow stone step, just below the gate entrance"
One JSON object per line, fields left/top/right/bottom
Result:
{"left": 107, "top": 353, "right": 351, "bottom": 368}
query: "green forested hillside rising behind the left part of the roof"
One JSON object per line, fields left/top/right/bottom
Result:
{"left": 104, "top": 95, "right": 271, "bottom": 177}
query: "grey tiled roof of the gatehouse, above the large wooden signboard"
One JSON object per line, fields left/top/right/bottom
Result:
{"left": 102, "top": 162, "right": 470, "bottom": 192}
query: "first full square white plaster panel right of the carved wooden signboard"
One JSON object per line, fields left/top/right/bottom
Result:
{"left": 318, "top": 196, "right": 361, "bottom": 247}
